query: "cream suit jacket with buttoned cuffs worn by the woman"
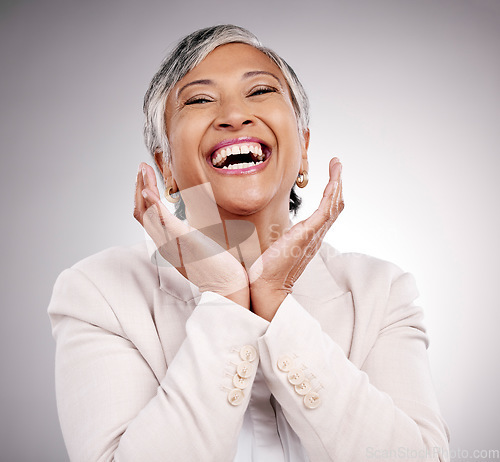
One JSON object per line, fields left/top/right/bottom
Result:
{"left": 49, "top": 243, "right": 449, "bottom": 462}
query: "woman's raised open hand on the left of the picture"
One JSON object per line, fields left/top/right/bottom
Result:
{"left": 134, "top": 163, "right": 250, "bottom": 309}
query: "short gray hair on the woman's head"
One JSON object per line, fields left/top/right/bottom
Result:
{"left": 144, "top": 24, "right": 309, "bottom": 160}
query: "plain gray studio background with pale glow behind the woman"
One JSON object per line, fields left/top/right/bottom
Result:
{"left": 0, "top": 0, "right": 500, "bottom": 462}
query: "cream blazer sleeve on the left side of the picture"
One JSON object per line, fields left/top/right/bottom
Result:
{"left": 49, "top": 269, "right": 268, "bottom": 462}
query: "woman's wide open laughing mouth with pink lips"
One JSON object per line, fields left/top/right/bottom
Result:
{"left": 210, "top": 141, "right": 271, "bottom": 170}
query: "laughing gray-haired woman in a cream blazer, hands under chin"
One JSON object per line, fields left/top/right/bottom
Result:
{"left": 49, "top": 26, "right": 448, "bottom": 462}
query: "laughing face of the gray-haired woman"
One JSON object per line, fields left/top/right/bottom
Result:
{"left": 166, "top": 43, "right": 308, "bottom": 215}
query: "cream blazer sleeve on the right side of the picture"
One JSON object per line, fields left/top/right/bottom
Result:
{"left": 258, "top": 273, "right": 449, "bottom": 462}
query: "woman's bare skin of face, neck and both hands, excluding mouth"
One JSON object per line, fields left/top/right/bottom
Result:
{"left": 134, "top": 43, "right": 344, "bottom": 321}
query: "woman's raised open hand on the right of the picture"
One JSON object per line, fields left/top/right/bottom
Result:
{"left": 248, "top": 157, "right": 344, "bottom": 321}
